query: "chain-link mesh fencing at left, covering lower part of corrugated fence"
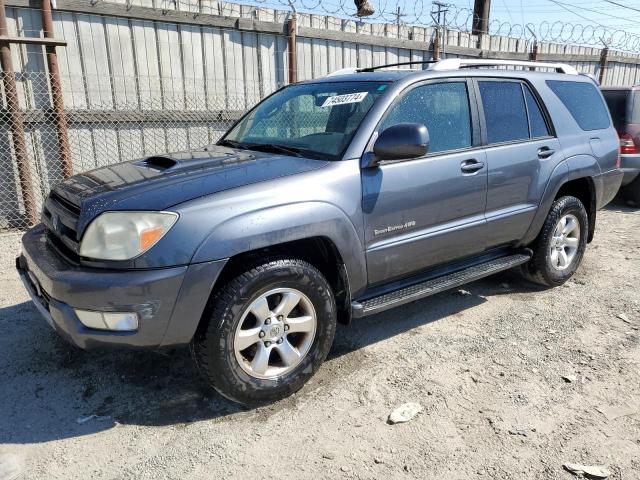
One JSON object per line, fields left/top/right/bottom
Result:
{"left": 0, "top": 72, "right": 266, "bottom": 231}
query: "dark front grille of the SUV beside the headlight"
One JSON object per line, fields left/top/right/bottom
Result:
{"left": 42, "top": 192, "right": 80, "bottom": 265}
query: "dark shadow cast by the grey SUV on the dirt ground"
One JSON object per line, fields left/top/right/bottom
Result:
{"left": 0, "top": 272, "right": 538, "bottom": 443}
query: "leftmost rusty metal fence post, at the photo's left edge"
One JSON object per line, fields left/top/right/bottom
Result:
{"left": 0, "top": 0, "right": 37, "bottom": 225}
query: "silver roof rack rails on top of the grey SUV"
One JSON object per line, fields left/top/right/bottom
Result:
{"left": 327, "top": 58, "right": 578, "bottom": 77}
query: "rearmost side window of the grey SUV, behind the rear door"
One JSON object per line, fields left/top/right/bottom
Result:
{"left": 547, "top": 80, "right": 611, "bottom": 130}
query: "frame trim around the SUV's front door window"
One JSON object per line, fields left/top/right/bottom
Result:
{"left": 366, "top": 77, "right": 482, "bottom": 158}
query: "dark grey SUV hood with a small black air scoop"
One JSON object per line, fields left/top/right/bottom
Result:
{"left": 54, "top": 146, "right": 329, "bottom": 233}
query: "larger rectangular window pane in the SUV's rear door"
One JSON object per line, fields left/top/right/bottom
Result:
{"left": 478, "top": 81, "right": 529, "bottom": 143}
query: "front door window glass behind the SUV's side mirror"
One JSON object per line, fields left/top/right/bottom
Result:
{"left": 378, "top": 82, "right": 471, "bottom": 153}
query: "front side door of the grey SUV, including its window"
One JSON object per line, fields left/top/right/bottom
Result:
{"left": 362, "top": 79, "right": 487, "bottom": 284}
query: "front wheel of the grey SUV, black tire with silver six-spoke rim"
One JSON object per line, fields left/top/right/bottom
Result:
{"left": 191, "top": 258, "right": 336, "bottom": 405}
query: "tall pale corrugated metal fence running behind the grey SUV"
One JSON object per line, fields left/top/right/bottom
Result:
{"left": 0, "top": 0, "right": 640, "bottom": 232}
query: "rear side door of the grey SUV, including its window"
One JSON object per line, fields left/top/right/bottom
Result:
{"left": 475, "top": 79, "right": 560, "bottom": 247}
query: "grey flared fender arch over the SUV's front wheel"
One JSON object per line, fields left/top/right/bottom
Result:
{"left": 192, "top": 201, "right": 366, "bottom": 292}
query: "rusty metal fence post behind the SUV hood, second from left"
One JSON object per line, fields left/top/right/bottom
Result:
{"left": 42, "top": 0, "right": 73, "bottom": 178}
